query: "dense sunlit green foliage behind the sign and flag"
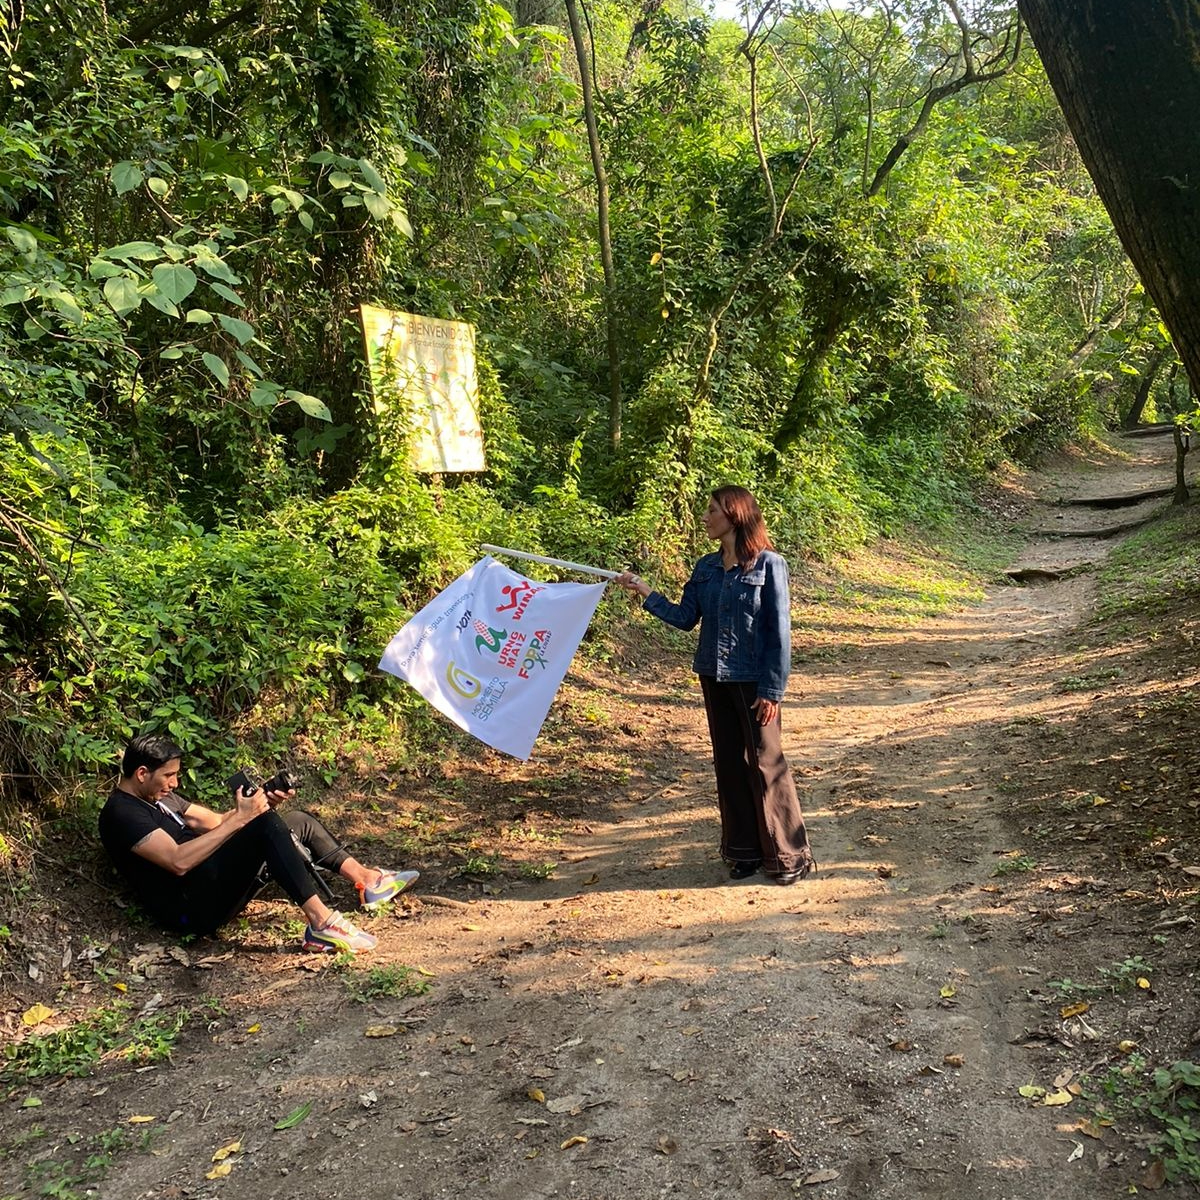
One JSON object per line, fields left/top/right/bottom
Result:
{"left": 0, "top": 0, "right": 1142, "bottom": 816}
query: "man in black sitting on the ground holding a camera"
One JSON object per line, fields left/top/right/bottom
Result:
{"left": 100, "top": 734, "right": 418, "bottom": 953}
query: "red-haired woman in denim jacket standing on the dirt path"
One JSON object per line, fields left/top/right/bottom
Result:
{"left": 614, "top": 485, "right": 817, "bottom": 884}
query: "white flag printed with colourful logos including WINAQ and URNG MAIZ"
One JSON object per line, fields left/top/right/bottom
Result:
{"left": 379, "top": 557, "right": 605, "bottom": 758}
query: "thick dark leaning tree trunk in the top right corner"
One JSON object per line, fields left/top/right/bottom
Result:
{"left": 1018, "top": 0, "right": 1200, "bottom": 398}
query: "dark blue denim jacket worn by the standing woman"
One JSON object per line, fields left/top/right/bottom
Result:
{"left": 642, "top": 550, "right": 792, "bottom": 701}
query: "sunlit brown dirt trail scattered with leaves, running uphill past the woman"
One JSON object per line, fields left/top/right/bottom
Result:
{"left": 0, "top": 437, "right": 1171, "bottom": 1200}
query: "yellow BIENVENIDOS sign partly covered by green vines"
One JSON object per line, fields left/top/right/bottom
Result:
{"left": 360, "top": 304, "right": 487, "bottom": 474}
